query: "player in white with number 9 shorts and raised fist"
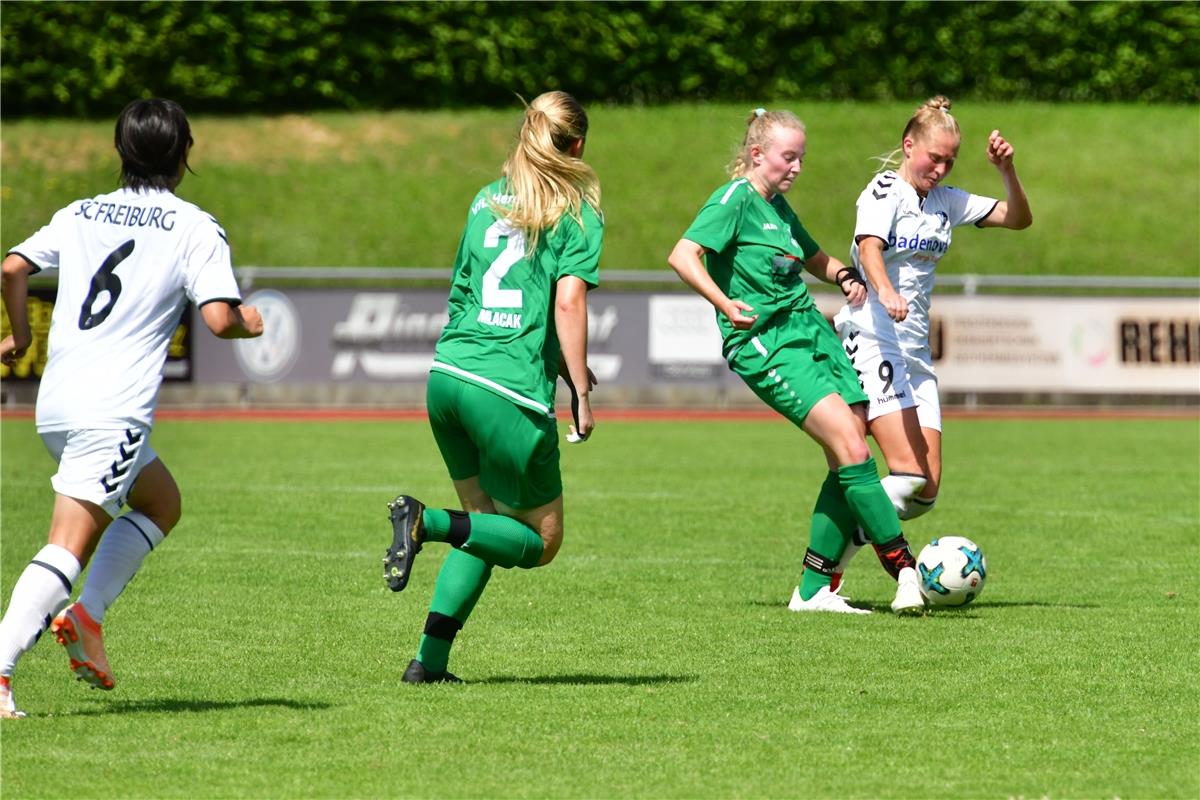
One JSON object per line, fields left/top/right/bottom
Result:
{"left": 834, "top": 96, "right": 1033, "bottom": 587}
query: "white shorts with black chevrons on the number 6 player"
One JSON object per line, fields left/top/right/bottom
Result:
{"left": 38, "top": 426, "right": 158, "bottom": 518}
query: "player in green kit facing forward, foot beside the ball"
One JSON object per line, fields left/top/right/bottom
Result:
{"left": 667, "top": 108, "right": 925, "bottom": 615}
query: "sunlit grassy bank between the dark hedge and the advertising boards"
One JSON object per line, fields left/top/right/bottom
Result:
{"left": 0, "top": 103, "right": 1200, "bottom": 277}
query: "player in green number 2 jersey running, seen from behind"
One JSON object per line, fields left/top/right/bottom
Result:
{"left": 384, "top": 91, "right": 604, "bottom": 684}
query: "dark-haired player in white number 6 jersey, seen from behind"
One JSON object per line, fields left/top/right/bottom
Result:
{"left": 0, "top": 98, "right": 263, "bottom": 717}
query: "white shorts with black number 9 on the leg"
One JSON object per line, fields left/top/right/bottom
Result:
{"left": 834, "top": 314, "right": 942, "bottom": 431}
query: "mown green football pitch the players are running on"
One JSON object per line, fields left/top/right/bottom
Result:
{"left": 0, "top": 415, "right": 1200, "bottom": 799}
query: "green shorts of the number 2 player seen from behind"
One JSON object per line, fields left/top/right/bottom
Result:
{"left": 425, "top": 372, "right": 563, "bottom": 509}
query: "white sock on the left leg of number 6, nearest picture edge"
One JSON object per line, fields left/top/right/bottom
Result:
{"left": 0, "top": 545, "right": 83, "bottom": 675}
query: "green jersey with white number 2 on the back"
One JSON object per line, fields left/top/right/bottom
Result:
{"left": 431, "top": 179, "right": 604, "bottom": 416}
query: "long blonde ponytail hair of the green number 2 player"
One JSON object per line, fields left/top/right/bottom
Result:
{"left": 496, "top": 91, "right": 600, "bottom": 252}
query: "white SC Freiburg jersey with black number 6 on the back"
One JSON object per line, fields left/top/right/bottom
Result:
{"left": 10, "top": 188, "right": 241, "bottom": 431}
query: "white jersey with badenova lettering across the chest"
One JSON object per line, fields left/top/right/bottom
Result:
{"left": 838, "top": 169, "right": 997, "bottom": 351}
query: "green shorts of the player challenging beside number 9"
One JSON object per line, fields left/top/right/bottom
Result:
{"left": 728, "top": 306, "right": 866, "bottom": 427}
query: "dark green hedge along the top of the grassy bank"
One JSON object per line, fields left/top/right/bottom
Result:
{"left": 0, "top": 0, "right": 1200, "bottom": 116}
